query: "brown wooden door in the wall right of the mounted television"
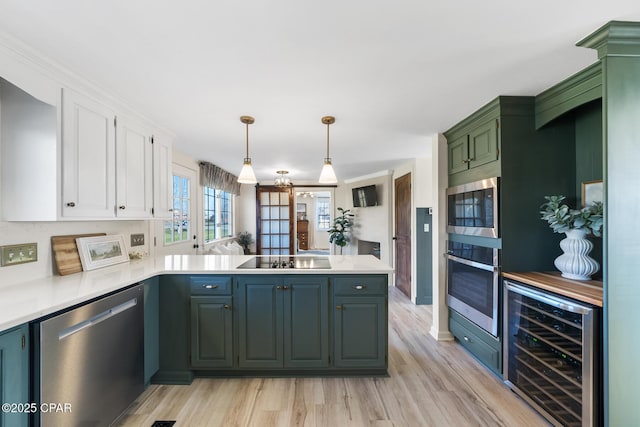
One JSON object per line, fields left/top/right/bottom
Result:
{"left": 395, "top": 173, "right": 411, "bottom": 298}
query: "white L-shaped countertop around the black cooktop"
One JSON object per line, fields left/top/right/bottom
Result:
{"left": 0, "top": 255, "right": 393, "bottom": 332}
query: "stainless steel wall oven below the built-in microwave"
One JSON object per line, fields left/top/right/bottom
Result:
{"left": 447, "top": 241, "right": 500, "bottom": 337}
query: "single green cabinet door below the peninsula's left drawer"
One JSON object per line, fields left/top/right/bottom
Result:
{"left": 191, "top": 296, "right": 233, "bottom": 368}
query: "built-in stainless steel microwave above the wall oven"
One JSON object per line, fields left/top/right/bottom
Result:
{"left": 447, "top": 177, "right": 500, "bottom": 237}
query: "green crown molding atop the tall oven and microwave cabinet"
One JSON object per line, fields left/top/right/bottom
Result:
{"left": 443, "top": 96, "right": 533, "bottom": 142}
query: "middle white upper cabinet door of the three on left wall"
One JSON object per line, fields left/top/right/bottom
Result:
{"left": 116, "top": 116, "right": 153, "bottom": 219}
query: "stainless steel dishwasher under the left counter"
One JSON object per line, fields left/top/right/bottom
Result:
{"left": 33, "top": 285, "right": 144, "bottom": 427}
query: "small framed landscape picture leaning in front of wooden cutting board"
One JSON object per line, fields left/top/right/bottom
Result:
{"left": 76, "top": 234, "right": 129, "bottom": 271}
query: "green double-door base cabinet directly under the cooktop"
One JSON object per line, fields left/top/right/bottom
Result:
{"left": 237, "top": 276, "right": 329, "bottom": 369}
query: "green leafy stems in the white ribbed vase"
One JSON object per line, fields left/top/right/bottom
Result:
{"left": 540, "top": 195, "right": 603, "bottom": 236}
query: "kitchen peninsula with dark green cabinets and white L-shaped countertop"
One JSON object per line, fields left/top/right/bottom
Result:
{"left": 0, "top": 255, "right": 393, "bottom": 426}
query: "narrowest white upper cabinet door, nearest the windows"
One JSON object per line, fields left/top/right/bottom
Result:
{"left": 153, "top": 134, "right": 173, "bottom": 219}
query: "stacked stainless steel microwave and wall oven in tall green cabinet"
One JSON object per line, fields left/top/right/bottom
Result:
{"left": 446, "top": 177, "right": 500, "bottom": 337}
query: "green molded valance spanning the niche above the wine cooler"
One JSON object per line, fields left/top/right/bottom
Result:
{"left": 535, "top": 61, "right": 602, "bottom": 129}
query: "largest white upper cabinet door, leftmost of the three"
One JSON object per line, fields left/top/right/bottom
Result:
{"left": 62, "top": 89, "right": 116, "bottom": 219}
